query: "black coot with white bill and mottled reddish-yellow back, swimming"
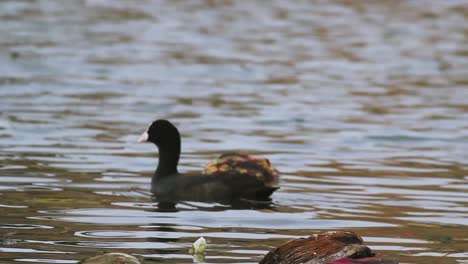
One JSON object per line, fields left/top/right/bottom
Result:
{"left": 138, "top": 119, "right": 279, "bottom": 203}
